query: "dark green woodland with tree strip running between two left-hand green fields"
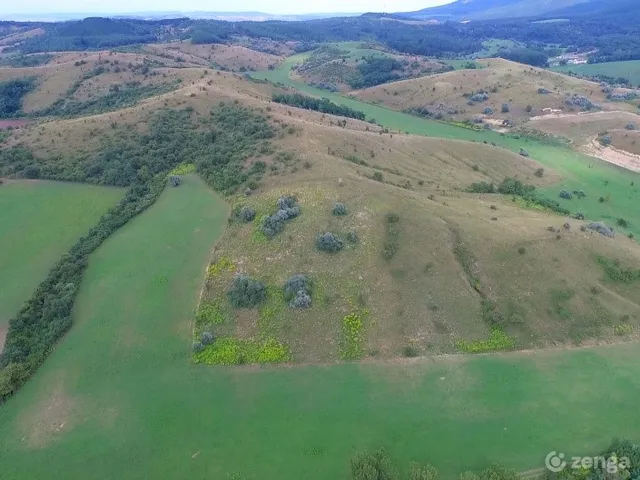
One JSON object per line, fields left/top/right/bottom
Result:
{"left": 0, "top": 104, "right": 274, "bottom": 401}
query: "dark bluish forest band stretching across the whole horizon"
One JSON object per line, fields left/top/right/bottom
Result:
{"left": 0, "top": 0, "right": 640, "bottom": 66}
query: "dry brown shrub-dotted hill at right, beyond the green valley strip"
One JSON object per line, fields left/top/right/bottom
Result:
{"left": 354, "top": 58, "right": 634, "bottom": 127}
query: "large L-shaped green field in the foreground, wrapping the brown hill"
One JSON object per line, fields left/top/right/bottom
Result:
{"left": 0, "top": 177, "right": 640, "bottom": 480}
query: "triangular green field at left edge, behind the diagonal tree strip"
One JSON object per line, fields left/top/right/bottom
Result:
{"left": 0, "top": 182, "right": 122, "bottom": 325}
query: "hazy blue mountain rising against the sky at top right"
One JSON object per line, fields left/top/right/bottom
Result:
{"left": 391, "top": 0, "right": 628, "bottom": 21}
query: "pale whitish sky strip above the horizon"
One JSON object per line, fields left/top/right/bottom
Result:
{"left": 0, "top": 0, "right": 452, "bottom": 16}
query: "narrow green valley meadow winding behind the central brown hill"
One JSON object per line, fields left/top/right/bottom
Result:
{"left": 252, "top": 54, "right": 640, "bottom": 237}
